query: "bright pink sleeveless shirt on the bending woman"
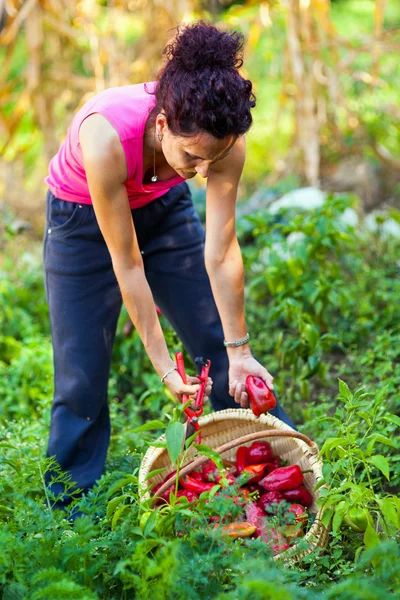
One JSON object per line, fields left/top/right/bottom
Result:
{"left": 45, "top": 81, "right": 185, "bottom": 208}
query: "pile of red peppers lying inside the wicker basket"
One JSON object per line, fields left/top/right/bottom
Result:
{"left": 153, "top": 441, "right": 313, "bottom": 554}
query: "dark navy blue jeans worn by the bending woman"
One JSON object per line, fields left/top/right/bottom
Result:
{"left": 43, "top": 183, "right": 293, "bottom": 502}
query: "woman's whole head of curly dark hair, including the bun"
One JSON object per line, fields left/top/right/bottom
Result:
{"left": 146, "top": 21, "right": 256, "bottom": 139}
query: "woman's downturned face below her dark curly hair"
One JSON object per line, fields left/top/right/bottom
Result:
{"left": 156, "top": 115, "right": 237, "bottom": 179}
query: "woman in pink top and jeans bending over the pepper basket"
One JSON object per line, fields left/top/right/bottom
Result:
{"left": 44, "top": 21, "right": 290, "bottom": 504}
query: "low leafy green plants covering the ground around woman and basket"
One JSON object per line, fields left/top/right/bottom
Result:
{"left": 0, "top": 196, "right": 400, "bottom": 600}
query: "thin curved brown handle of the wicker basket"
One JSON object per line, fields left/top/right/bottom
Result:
{"left": 151, "top": 429, "right": 318, "bottom": 503}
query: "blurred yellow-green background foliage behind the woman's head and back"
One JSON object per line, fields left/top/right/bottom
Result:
{"left": 0, "top": 0, "right": 400, "bottom": 230}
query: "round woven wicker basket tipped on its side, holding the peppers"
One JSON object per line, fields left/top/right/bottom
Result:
{"left": 139, "top": 409, "right": 328, "bottom": 563}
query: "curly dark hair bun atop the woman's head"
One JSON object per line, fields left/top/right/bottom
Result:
{"left": 164, "top": 21, "right": 244, "bottom": 71}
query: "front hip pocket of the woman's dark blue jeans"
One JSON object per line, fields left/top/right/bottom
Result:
{"left": 46, "top": 190, "right": 85, "bottom": 238}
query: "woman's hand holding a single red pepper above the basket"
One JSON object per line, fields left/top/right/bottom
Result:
{"left": 229, "top": 356, "right": 274, "bottom": 408}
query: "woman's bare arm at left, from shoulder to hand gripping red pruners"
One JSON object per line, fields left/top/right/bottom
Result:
{"left": 79, "top": 114, "right": 202, "bottom": 394}
